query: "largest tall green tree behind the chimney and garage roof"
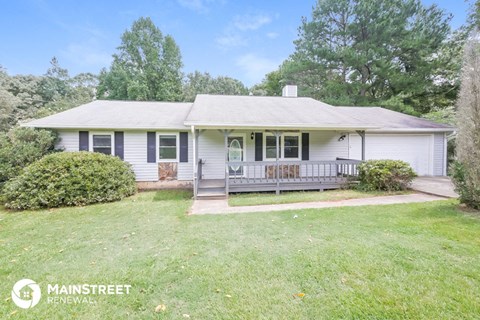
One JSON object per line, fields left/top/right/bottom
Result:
{"left": 283, "top": 0, "right": 450, "bottom": 113}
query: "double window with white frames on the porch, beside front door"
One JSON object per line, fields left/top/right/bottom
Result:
{"left": 264, "top": 133, "right": 301, "bottom": 160}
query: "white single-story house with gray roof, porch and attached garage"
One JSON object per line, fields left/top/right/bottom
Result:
{"left": 25, "top": 86, "right": 453, "bottom": 197}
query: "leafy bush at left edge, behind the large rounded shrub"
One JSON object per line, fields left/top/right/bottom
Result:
{"left": 0, "top": 127, "right": 58, "bottom": 189}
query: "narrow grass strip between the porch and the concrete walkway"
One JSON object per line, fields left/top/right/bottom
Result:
{"left": 228, "top": 190, "right": 410, "bottom": 206}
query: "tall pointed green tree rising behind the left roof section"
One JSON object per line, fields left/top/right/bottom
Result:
{"left": 97, "top": 18, "right": 183, "bottom": 101}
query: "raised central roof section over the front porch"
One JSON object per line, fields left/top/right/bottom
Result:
{"left": 185, "top": 95, "right": 377, "bottom": 129}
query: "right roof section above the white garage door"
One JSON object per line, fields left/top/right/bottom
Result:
{"left": 335, "top": 107, "right": 455, "bottom": 131}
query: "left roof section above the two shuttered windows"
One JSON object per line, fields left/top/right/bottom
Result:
{"left": 24, "top": 100, "right": 192, "bottom": 129}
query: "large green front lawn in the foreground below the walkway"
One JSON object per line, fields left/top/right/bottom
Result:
{"left": 0, "top": 192, "right": 480, "bottom": 319}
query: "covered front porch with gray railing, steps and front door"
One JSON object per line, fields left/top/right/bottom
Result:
{"left": 192, "top": 128, "right": 365, "bottom": 199}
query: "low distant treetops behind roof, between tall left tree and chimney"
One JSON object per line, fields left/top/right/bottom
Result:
{"left": 183, "top": 71, "right": 248, "bottom": 101}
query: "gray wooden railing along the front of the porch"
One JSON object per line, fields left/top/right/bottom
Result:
{"left": 225, "top": 159, "right": 361, "bottom": 192}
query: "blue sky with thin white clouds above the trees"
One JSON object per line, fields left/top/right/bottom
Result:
{"left": 0, "top": 0, "right": 469, "bottom": 87}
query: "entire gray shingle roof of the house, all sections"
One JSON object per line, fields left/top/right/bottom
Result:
{"left": 23, "top": 95, "right": 454, "bottom": 131}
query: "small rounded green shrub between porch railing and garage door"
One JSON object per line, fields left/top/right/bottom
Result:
{"left": 358, "top": 160, "right": 416, "bottom": 191}
